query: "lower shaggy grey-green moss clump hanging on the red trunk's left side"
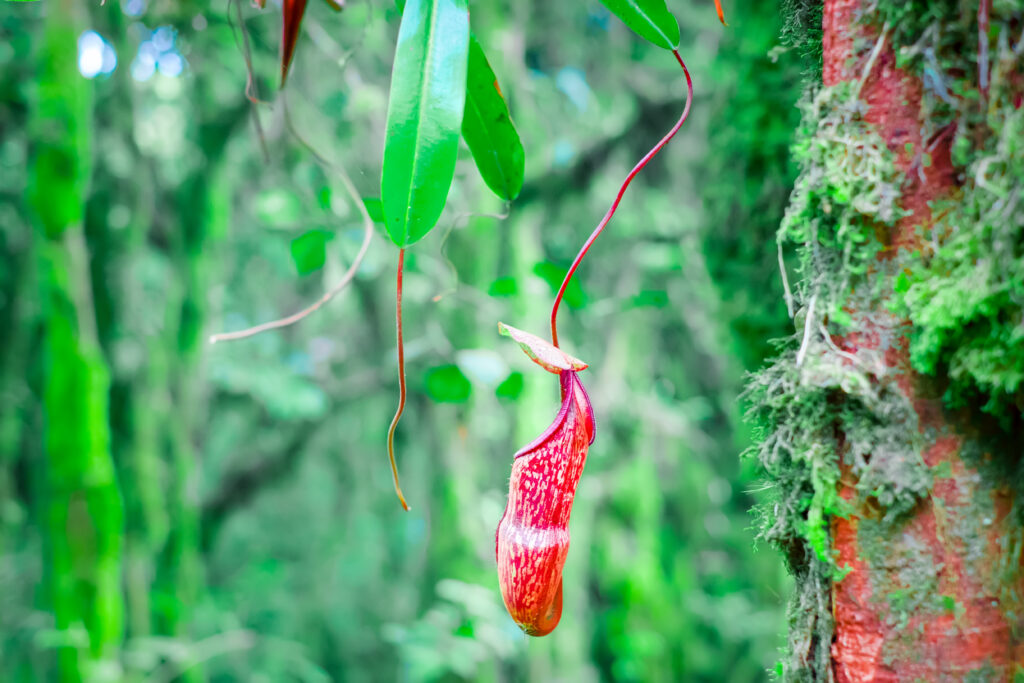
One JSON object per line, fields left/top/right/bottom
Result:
{"left": 748, "top": 337, "right": 937, "bottom": 681}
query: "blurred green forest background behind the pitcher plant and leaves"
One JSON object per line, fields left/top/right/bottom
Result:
{"left": 0, "top": 0, "right": 801, "bottom": 682}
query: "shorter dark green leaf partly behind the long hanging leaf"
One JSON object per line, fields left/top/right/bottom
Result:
{"left": 462, "top": 36, "right": 526, "bottom": 201}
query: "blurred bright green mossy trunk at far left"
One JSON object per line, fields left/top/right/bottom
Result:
{"left": 30, "top": 0, "right": 123, "bottom": 681}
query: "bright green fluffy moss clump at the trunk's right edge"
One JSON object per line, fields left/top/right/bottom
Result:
{"left": 896, "top": 102, "right": 1024, "bottom": 423}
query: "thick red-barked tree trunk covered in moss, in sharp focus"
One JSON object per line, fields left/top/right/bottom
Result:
{"left": 752, "top": 0, "right": 1024, "bottom": 682}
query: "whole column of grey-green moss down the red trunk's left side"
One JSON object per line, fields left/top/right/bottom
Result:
{"left": 749, "top": 72, "right": 931, "bottom": 681}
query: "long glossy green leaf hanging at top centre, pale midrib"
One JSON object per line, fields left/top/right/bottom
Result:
{"left": 381, "top": 0, "right": 469, "bottom": 248}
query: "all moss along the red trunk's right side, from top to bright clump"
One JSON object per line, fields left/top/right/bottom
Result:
{"left": 862, "top": 0, "right": 1024, "bottom": 427}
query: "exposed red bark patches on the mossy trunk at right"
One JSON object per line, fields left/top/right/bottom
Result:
{"left": 822, "top": 0, "right": 1024, "bottom": 683}
